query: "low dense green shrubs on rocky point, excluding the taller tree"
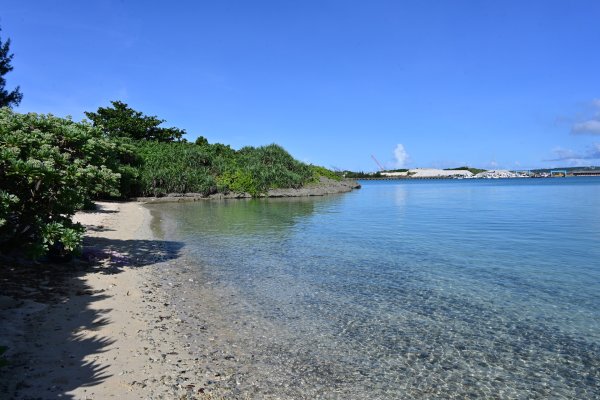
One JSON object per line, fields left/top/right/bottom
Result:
{"left": 129, "top": 142, "right": 323, "bottom": 196}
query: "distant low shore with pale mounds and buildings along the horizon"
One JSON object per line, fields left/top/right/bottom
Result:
{"left": 339, "top": 166, "right": 600, "bottom": 180}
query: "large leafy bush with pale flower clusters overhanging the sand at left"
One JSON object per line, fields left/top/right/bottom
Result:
{"left": 0, "top": 108, "right": 121, "bottom": 255}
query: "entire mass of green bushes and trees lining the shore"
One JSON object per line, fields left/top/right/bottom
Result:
{"left": 0, "top": 102, "right": 340, "bottom": 256}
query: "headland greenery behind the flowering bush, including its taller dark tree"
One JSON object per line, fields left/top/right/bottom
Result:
{"left": 85, "top": 101, "right": 339, "bottom": 197}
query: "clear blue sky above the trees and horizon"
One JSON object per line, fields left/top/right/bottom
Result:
{"left": 0, "top": 0, "right": 600, "bottom": 171}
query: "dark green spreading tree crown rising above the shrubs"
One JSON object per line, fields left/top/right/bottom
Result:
{"left": 85, "top": 101, "right": 185, "bottom": 142}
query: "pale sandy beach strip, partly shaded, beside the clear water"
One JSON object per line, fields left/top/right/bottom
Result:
{"left": 0, "top": 202, "right": 216, "bottom": 399}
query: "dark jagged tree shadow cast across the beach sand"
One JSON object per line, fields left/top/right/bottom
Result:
{"left": 0, "top": 238, "right": 182, "bottom": 399}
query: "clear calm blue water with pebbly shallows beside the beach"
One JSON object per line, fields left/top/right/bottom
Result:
{"left": 149, "top": 178, "right": 600, "bottom": 399}
